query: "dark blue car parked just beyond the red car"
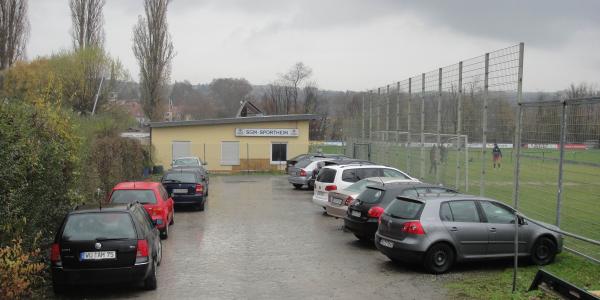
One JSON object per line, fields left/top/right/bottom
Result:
{"left": 160, "top": 168, "right": 209, "bottom": 211}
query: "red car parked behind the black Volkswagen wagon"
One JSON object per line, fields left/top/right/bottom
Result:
{"left": 108, "top": 181, "right": 175, "bottom": 239}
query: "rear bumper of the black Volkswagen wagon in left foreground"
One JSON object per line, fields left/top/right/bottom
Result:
{"left": 52, "top": 262, "right": 151, "bottom": 285}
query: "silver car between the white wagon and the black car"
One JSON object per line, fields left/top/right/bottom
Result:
{"left": 325, "top": 177, "right": 419, "bottom": 218}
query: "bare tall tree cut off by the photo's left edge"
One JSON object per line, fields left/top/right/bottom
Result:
{"left": 0, "top": 0, "right": 29, "bottom": 70}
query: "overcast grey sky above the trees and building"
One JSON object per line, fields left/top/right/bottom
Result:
{"left": 27, "top": 0, "right": 600, "bottom": 91}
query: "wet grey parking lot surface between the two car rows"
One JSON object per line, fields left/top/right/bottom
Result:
{"left": 58, "top": 175, "right": 444, "bottom": 299}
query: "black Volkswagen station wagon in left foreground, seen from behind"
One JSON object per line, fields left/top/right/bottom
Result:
{"left": 50, "top": 203, "right": 162, "bottom": 294}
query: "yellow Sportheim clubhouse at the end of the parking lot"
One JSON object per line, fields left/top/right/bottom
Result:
{"left": 149, "top": 113, "right": 319, "bottom": 173}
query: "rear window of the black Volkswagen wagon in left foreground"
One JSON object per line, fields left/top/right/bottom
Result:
{"left": 62, "top": 213, "right": 136, "bottom": 241}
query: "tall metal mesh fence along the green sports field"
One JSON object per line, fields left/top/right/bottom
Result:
{"left": 343, "top": 43, "right": 600, "bottom": 259}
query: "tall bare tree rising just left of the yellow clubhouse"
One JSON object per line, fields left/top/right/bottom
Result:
{"left": 133, "top": 0, "right": 175, "bottom": 121}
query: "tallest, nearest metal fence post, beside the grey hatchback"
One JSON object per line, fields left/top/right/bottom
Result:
{"left": 512, "top": 43, "right": 525, "bottom": 293}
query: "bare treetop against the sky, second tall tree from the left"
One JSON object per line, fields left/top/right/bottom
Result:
{"left": 69, "top": 0, "right": 105, "bottom": 49}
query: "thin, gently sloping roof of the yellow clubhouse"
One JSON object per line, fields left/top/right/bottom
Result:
{"left": 149, "top": 114, "right": 320, "bottom": 128}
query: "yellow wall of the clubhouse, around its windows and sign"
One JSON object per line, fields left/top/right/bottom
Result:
{"left": 151, "top": 121, "right": 309, "bottom": 172}
